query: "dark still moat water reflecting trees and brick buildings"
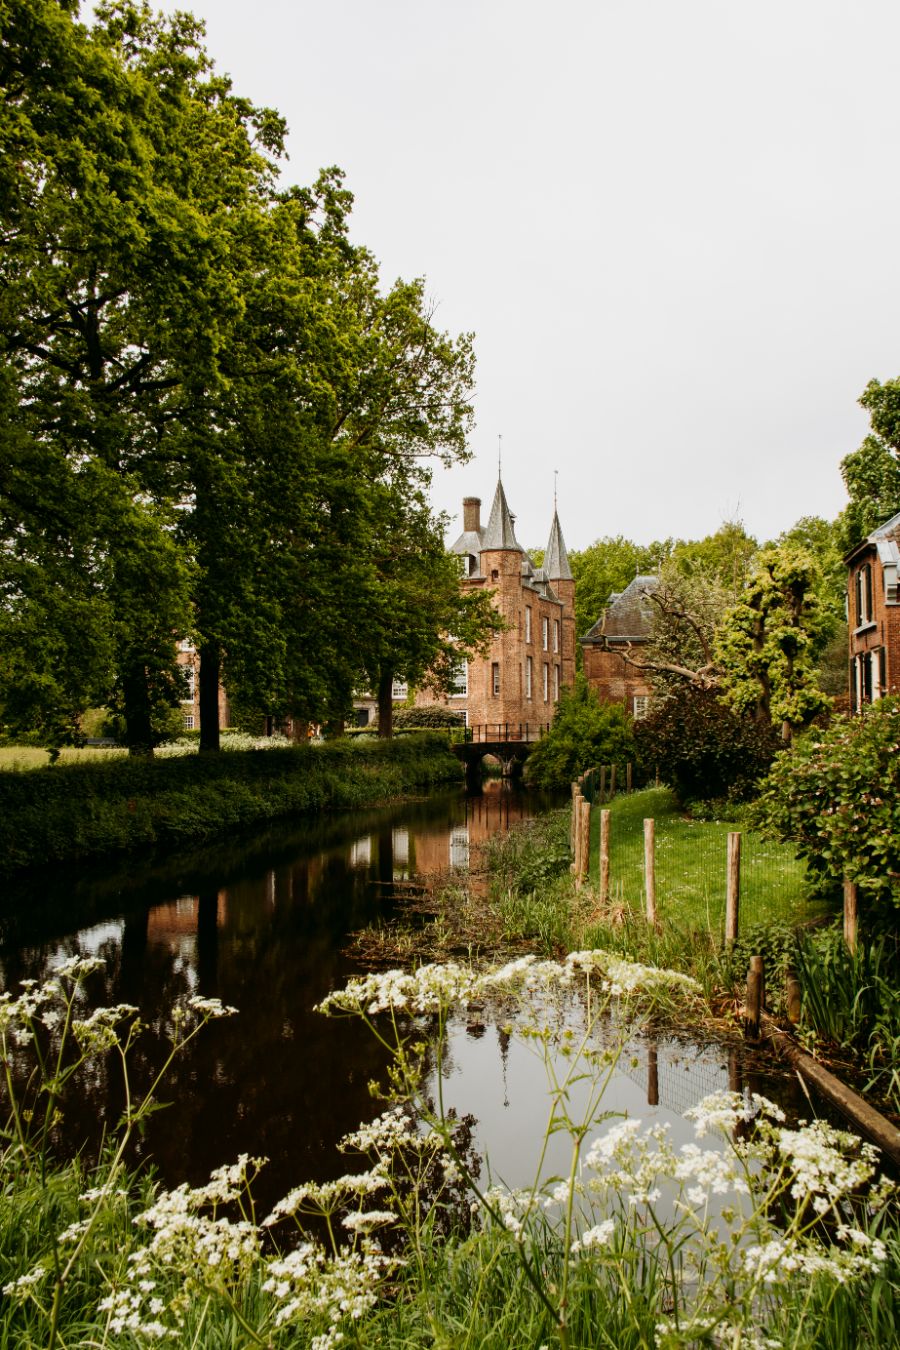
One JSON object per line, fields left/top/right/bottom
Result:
{"left": 0, "top": 782, "right": 814, "bottom": 1212}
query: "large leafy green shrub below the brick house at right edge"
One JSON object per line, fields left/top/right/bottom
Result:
{"left": 757, "top": 698, "right": 900, "bottom": 910}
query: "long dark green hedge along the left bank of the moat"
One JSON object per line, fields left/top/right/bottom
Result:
{"left": 0, "top": 734, "right": 463, "bottom": 872}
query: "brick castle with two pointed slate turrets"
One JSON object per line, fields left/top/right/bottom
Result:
{"left": 416, "top": 479, "right": 575, "bottom": 728}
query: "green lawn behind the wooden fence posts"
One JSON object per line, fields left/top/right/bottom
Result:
{"left": 591, "top": 788, "right": 819, "bottom": 933}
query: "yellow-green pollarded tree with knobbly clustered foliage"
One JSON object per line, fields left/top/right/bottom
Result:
{"left": 715, "top": 544, "right": 830, "bottom": 740}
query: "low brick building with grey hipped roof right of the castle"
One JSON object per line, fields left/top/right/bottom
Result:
{"left": 580, "top": 576, "right": 658, "bottom": 717}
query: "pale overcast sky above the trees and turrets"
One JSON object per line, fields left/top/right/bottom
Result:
{"left": 142, "top": 0, "right": 900, "bottom": 548}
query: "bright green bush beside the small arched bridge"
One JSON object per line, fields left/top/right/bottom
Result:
{"left": 525, "top": 675, "right": 634, "bottom": 787}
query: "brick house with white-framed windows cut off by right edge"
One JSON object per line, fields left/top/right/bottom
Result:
{"left": 845, "top": 514, "right": 900, "bottom": 711}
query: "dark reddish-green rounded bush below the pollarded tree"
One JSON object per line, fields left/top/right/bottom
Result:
{"left": 634, "top": 686, "right": 780, "bottom": 802}
